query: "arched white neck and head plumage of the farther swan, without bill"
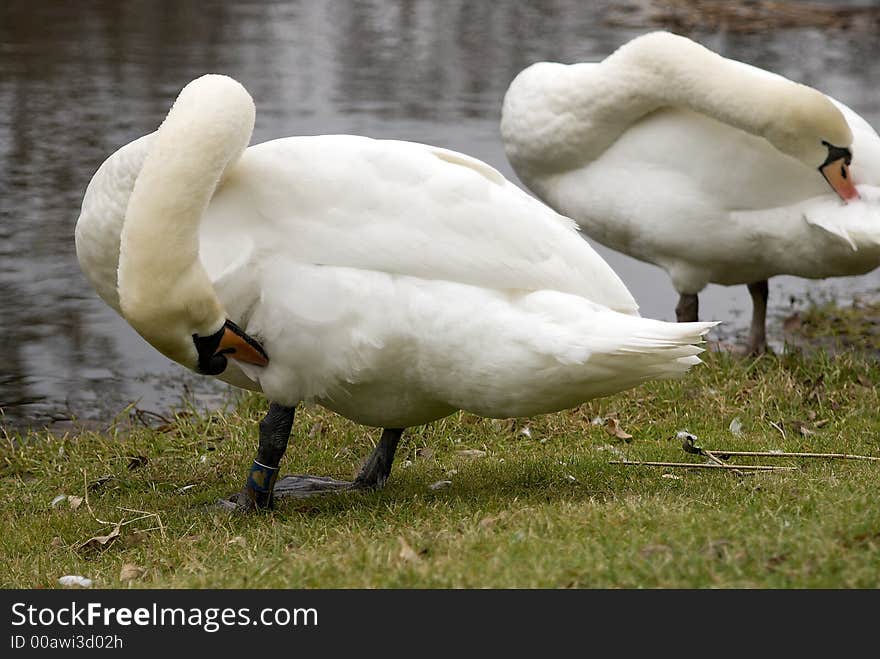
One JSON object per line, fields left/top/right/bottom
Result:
{"left": 501, "top": 32, "right": 852, "bottom": 178}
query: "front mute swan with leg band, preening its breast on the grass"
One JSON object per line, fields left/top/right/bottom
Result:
{"left": 76, "top": 75, "right": 713, "bottom": 509}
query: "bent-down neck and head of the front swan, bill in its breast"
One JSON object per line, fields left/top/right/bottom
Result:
{"left": 117, "top": 75, "right": 268, "bottom": 375}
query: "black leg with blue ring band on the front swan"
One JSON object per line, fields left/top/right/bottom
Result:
{"left": 221, "top": 403, "right": 296, "bottom": 510}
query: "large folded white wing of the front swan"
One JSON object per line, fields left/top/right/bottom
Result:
{"left": 203, "top": 135, "right": 637, "bottom": 313}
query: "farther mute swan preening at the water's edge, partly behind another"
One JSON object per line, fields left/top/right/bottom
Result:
{"left": 501, "top": 32, "right": 880, "bottom": 354}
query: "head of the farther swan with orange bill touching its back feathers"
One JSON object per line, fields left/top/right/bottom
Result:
{"left": 765, "top": 85, "right": 859, "bottom": 202}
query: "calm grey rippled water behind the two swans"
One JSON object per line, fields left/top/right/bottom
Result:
{"left": 0, "top": 0, "right": 880, "bottom": 434}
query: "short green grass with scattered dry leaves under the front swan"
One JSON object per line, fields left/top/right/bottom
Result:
{"left": 0, "top": 330, "right": 880, "bottom": 588}
